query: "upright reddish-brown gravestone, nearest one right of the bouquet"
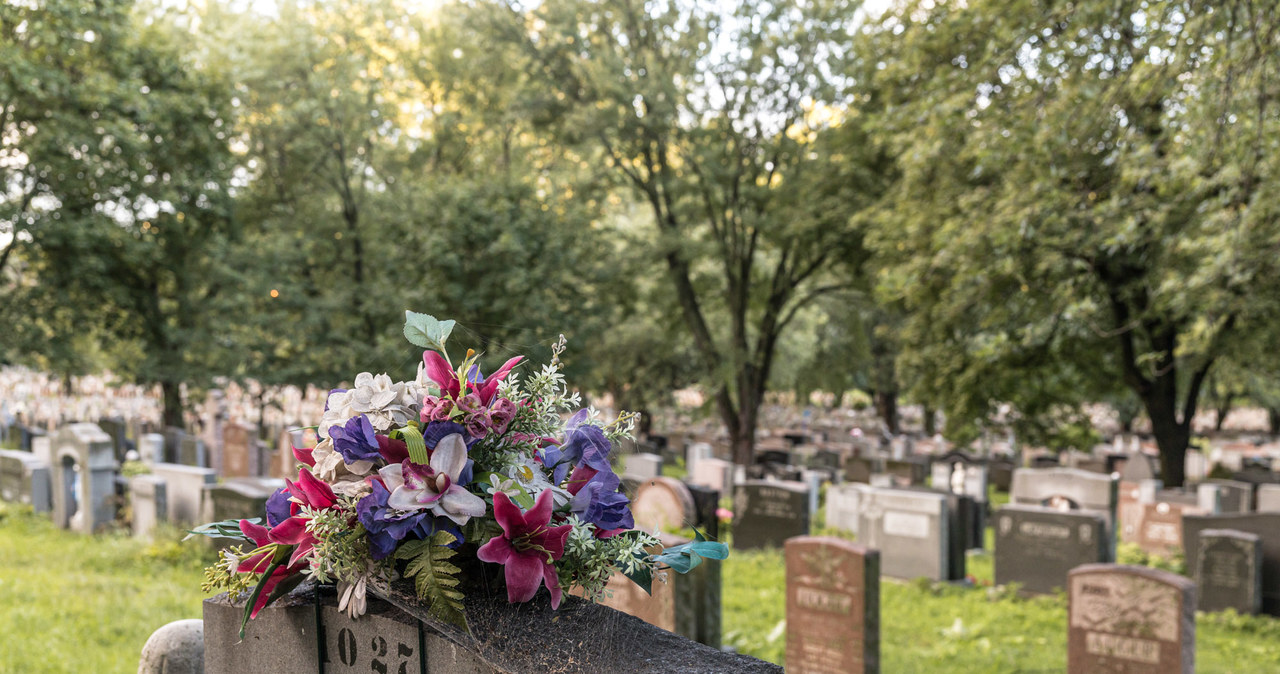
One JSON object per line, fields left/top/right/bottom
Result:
{"left": 786, "top": 536, "right": 879, "bottom": 674}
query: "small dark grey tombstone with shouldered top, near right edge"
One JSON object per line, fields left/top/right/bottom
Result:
{"left": 1196, "top": 529, "right": 1262, "bottom": 614}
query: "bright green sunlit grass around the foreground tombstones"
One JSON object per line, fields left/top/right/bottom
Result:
{"left": 0, "top": 505, "right": 1280, "bottom": 674}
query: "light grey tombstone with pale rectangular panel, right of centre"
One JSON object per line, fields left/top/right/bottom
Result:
{"left": 858, "top": 487, "right": 959, "bottom": 581}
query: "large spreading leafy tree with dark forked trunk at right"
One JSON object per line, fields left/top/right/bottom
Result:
{"left": 855, "top": 0, "right": 1280, "bottom": 486}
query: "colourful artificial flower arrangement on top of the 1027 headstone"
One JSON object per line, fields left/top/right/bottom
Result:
{"left": 192, "top": 312, "right": 728, "bottom": 638}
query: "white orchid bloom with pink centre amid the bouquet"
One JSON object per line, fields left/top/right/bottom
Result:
{"left": 378, "top": 434, "right": 485, "bottom": 524}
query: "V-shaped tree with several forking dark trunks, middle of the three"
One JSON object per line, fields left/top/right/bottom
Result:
{"left": 498, "top": 0, "right": 880, "bottom": 463}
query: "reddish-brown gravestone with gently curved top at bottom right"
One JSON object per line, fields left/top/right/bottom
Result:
{"left": 1066, "top": 564, "right": 1196, "bottom": 674}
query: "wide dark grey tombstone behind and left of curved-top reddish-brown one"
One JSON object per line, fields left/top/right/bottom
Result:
{"left": 995, "top": 505, "right": 1108, "bottom": 593}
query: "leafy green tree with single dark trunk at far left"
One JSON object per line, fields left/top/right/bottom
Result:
{"left": 0, "top": 1, "right": 234, "bottom": 425}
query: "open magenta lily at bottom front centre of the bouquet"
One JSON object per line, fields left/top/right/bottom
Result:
{"left": 476, "top": 490, "right": 573, "bottom": 609}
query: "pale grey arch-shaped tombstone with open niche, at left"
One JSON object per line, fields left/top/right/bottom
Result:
{"left": 50, "top": 423, "right": 118, "bottom": 533}
